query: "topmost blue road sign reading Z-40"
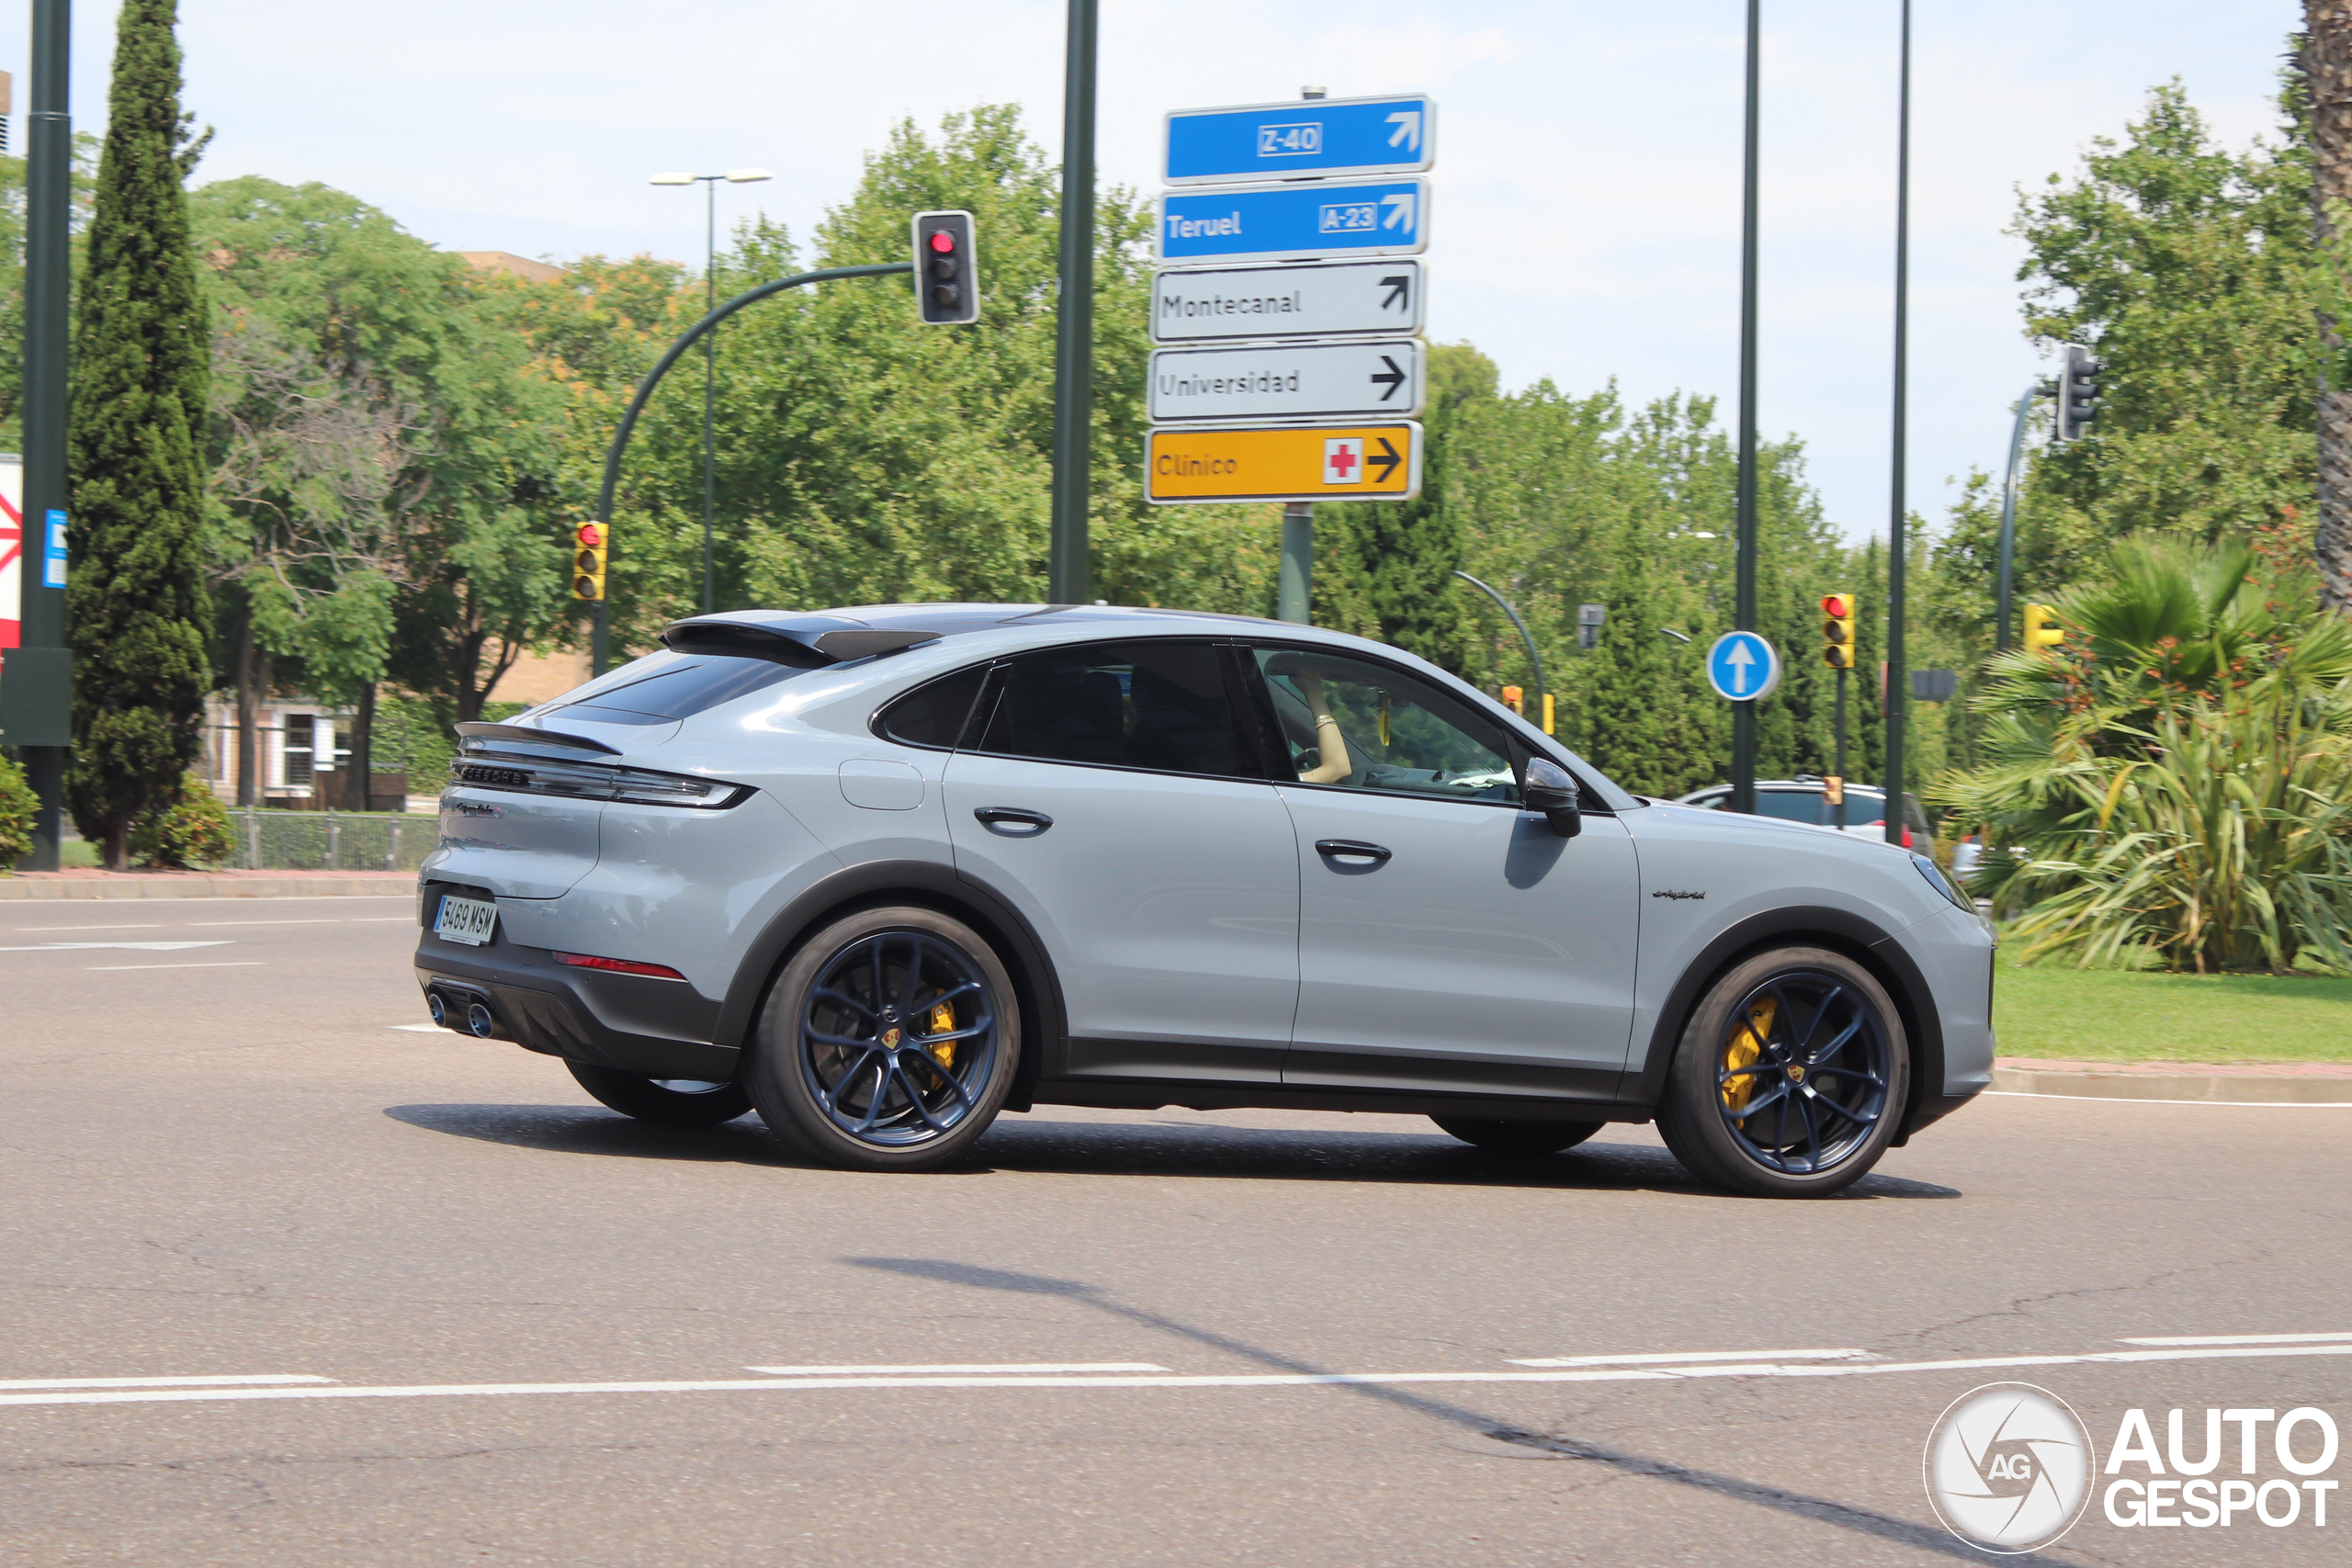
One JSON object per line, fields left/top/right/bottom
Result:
{"left": 1167, "top": 92, "right": 1437, "bottom": 186}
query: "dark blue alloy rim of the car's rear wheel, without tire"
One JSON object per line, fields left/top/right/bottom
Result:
{"left": 799, "top": 931, "right": 997, "bottom": 1149}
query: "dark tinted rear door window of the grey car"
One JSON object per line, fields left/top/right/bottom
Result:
{"left": 978, "top": 642, "right": 1253, "bottom": 778}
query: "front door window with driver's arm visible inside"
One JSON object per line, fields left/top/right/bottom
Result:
{"left": 1251, "top": 649, "right": 1520, "bottom": 802}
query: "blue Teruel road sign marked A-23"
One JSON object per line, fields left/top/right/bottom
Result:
{"left": 1159, "top": 179, "right": 1430, "bottom": 261}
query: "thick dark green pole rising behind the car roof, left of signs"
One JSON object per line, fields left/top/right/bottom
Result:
{"left": 1045, "top": 0, "right": 1096, "bottom": 604}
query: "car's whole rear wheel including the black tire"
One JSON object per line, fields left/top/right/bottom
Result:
{"left": 743, "top": 908, "right": 1021, "bottom": 1170}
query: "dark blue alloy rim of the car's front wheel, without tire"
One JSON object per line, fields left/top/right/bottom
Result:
{"left": 1714, "top": 968, "right": 1894, "bottom": 1176}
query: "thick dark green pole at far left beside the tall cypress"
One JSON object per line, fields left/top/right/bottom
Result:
{"left": 5, "top": 0, "right": 73, "bottom": 872}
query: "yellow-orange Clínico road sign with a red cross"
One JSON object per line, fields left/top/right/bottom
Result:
{"left": 1143, "top": 419, "right": 1420, "bottom": 501}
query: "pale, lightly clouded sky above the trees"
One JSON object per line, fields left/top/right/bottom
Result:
{"left": 0, "top": 0, "right": 2301, "bottom": 538}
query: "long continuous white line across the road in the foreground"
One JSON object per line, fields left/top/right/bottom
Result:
{"left": 14, "top": 1345, "right": 2352, "bottom": 1405}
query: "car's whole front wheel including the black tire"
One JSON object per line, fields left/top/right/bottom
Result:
{"left": 1658, "top": 947, "right": 1910, "bottom": 1197}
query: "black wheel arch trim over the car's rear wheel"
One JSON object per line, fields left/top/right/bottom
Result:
{"left": 715, "top": 861, "right": 1068, "bottom": 1110}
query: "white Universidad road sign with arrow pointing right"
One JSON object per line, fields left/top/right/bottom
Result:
{"left": 1150, "top": 339, "right": 1425, "bottom": 423}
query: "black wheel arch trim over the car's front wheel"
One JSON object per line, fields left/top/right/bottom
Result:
{"left": 1621, "top": 905, "right": 1943, "bottom": 1147}
